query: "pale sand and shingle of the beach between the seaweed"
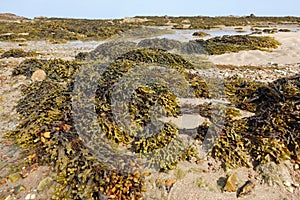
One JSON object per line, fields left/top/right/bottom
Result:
{"left": 0, "top": 21, "right": 300, "bottom": 200}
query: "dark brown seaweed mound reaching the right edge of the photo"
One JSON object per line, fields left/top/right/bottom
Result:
{"left": 198, "top": 75, "right": 300, "bottom": 168}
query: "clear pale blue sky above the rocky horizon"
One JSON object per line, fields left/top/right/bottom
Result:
{"left": 0, "top": 0, "right": 300, "bottom": 19}
